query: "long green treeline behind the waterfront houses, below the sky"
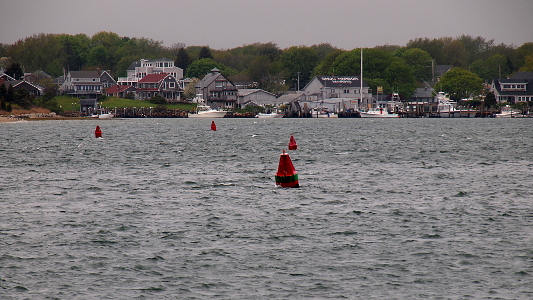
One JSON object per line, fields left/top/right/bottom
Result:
{"left": 0, "top": 32, "right": 533, "bottom": 97}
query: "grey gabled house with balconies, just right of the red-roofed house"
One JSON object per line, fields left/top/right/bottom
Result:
{"left": 195, "top": 68, "right": 237, "bottom": 108}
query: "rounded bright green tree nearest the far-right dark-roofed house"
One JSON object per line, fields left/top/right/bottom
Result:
{"left": 435, "top": 68, "right": 483, "bottom": 100}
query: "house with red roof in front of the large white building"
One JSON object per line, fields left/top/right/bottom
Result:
{"left": 135, "top": 73, "right": 183, "bottom": 103}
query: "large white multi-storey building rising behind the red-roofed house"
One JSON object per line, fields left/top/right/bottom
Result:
{"left": 117, "top": 58, "right": 183, "bottom": 88}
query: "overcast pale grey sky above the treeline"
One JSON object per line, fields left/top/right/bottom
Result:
{"left": 0, "top": 0, "right": 533, "bottom": 50}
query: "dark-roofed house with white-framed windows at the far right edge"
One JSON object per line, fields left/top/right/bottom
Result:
{"left": 490, "top": 72, "right": 533, "bottom": 104}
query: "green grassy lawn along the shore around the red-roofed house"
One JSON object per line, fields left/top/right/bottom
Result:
{"left": 56, "top": 96, "right": 196, "bottom": 110}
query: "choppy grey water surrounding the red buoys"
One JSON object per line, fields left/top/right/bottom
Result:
{"left": 0, "top": 119, "right": 533, "bottom": 299}
